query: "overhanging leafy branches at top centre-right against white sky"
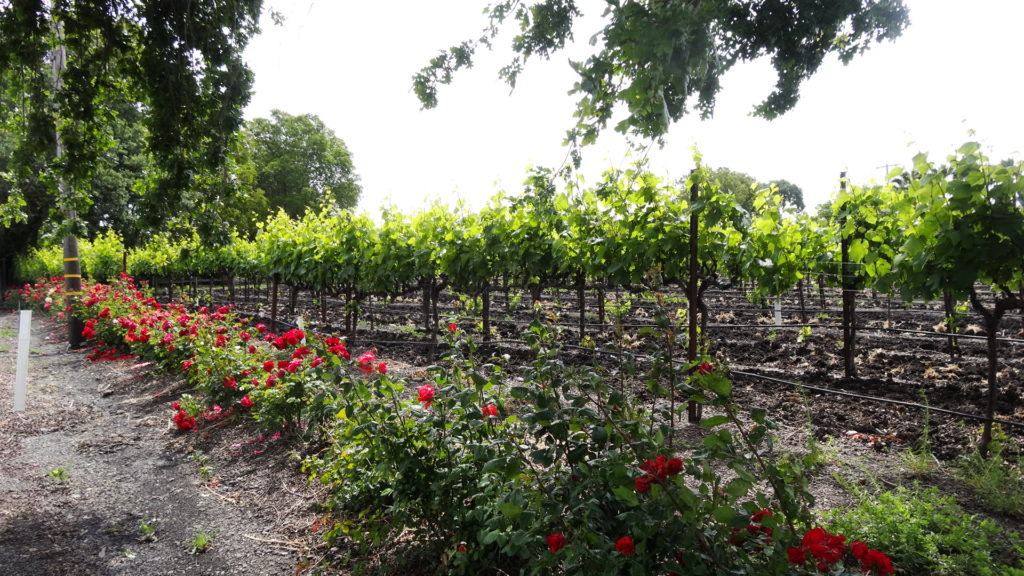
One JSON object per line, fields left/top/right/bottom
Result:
{"left": 414, "top": 0, "right": 908, "bottom": 145}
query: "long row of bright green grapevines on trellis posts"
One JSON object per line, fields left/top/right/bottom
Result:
{"left": 19, "top": 142, "right": 1024, "bottom": 453}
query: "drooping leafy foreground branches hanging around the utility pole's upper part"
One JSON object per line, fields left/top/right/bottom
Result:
{"left": 0, "top": 0, "right": 262, "bottom": 235}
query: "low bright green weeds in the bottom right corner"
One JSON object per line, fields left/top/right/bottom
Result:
{"left": 826, "top": 487, "right": 1024, "bottom": 576}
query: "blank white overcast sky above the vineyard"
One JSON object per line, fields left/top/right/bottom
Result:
{"left": 246, "top": 0, "right": 1024, "bottom": 214}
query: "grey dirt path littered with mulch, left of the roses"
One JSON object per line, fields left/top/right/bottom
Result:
{"left": 0, "top": 313, "right": 317, "bottom": 576}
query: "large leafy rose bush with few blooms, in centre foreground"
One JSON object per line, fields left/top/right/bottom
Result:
{"left": 307, "top": 323, "right": 827, "bottom": 575}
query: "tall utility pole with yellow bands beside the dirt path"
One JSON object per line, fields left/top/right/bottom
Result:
{"left": 47, "top": 2, "right": 83, "bottom": 348}
